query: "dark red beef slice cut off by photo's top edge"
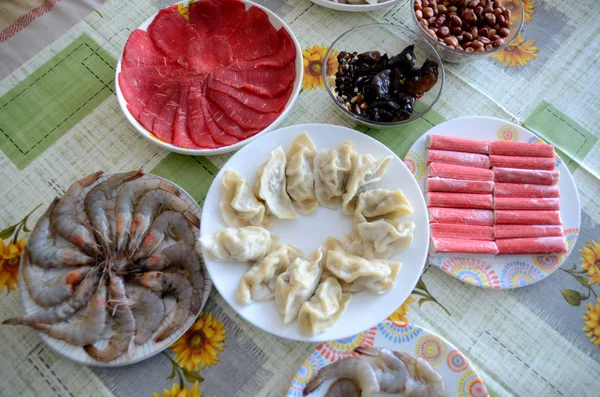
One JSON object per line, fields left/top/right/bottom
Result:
{"left": 189, "top": 0, "right": 246, "bottom": 37}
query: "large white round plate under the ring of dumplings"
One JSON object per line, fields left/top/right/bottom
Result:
{"left": 200, "top": 124, "right": 429, "bottom": 342}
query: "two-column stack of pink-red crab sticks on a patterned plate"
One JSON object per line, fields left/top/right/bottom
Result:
{"left": 425, "top": 135, "right": 567, "bottom": 255}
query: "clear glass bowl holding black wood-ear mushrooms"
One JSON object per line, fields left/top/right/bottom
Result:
{"left": 323, "top": 23, "right": 444, "bottom": 127}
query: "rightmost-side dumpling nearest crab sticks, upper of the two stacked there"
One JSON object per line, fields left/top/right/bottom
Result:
{"left": 354, "top": 189, "right": 414, "bottom": 223}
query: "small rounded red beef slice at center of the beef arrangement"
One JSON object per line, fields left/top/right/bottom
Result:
{"left": 185, "top": 35, "right": 233, "bottom": 73}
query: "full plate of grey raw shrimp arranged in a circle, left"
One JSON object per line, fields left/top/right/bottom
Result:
{"left": 3, "top": 170, "right": 212, "bottom": 367}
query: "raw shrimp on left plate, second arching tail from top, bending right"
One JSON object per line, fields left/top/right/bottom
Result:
{"left": 115, "top": 178, "right": 181, "bottom": 252}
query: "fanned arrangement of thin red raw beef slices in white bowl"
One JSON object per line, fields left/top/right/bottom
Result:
{"left": 119, "top": 0, "right": 296, "bottom": 149}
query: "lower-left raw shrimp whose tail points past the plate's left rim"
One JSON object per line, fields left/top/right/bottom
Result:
{"left": 29, "top": 273, "right": 107, "bottom": 346}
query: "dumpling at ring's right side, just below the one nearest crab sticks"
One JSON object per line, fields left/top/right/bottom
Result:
{"left": 343, "top": 219, "right": 415, "bottom": 259}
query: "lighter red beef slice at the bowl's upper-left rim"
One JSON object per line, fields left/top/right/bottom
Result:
{"left": 121, "top": 29, "right": 177, "bottom": 69}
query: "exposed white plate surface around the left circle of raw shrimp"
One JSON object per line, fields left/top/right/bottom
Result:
{"left": 19, "top": 174, "right": 212, "bottom": 367}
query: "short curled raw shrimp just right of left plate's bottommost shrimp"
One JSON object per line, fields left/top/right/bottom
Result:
{"left": 127, "top": 285, "right": 167, "bottom": 345}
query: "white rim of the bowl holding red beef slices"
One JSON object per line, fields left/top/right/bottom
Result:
{"left": 115, "top": 0, "right": 304, "bottom": 156}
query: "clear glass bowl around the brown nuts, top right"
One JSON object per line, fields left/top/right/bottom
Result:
{"left": 410, "top": 0, "right": 525, "bottom": 63}
